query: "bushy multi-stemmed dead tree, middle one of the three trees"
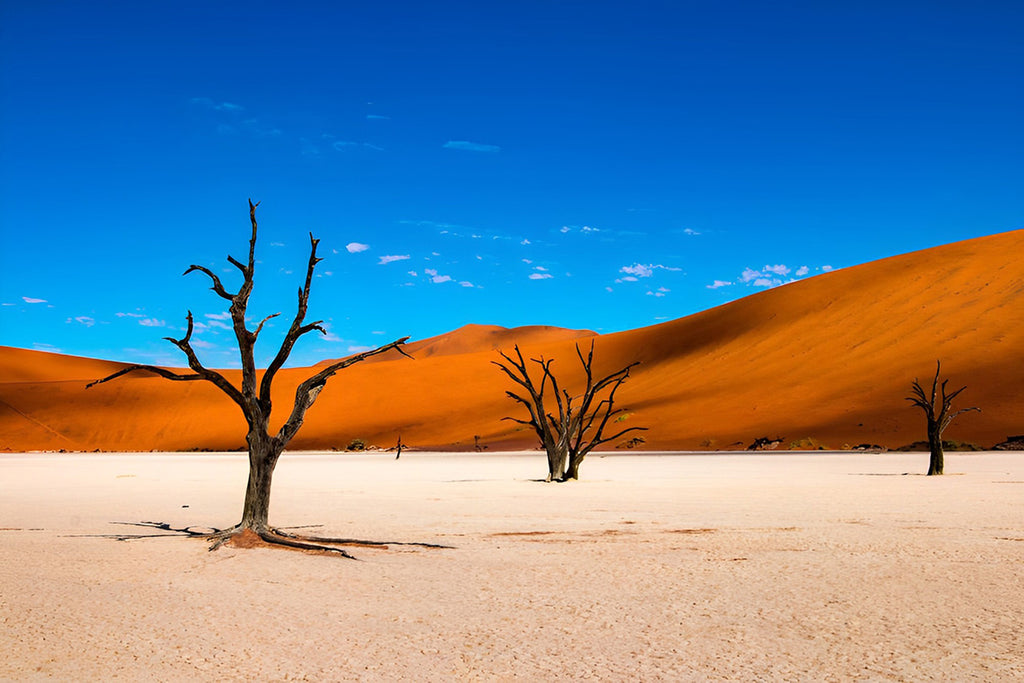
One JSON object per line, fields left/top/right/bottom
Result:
{"left": 492, "top": 342, "right": 646, "bottom": 481}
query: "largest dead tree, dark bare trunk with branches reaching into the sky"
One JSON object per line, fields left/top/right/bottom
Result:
{"left": 86, "top": 200, "right": 412, "bottom": 557}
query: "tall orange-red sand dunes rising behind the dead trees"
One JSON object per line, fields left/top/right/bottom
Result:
{"left": 0, "top": 230, "right": 1024, "bottom": 451}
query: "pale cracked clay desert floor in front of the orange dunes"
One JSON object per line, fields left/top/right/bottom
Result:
{"left": 0, "top": 453, "right": 1024, "bottom": 681}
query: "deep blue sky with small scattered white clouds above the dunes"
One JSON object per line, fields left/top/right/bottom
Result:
{"left": 0, "top": 0, "right": 1024, "bottom": 367}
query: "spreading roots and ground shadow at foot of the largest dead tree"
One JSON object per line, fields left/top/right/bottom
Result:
{"left": 75, "top": 521, "right": 452, "bottom": 560}
